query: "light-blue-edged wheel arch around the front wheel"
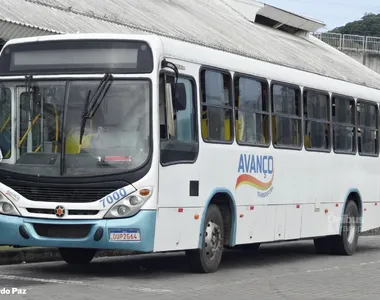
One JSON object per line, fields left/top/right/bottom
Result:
{"left": 198, "top": 188, "right": 236, "bottom": 249}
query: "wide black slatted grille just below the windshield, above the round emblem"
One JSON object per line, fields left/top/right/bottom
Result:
{"left": 4, "top": 185, "right": 115, "bottom": 203}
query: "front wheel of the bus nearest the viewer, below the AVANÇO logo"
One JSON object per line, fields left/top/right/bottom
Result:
{"left": 186, "top": 204, "right": 224, "bottom": 273}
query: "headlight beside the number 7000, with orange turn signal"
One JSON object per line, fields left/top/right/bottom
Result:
{"left": 104, "top": 188, "right": 153, "bottom": 219}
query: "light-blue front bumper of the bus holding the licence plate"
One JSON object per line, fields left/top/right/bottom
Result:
{"left": 0, "top": 211, "right": 156, "bottom": 252}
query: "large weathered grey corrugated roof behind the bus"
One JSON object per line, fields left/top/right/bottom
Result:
{"left": 0, "top": 0, "right": 380, "bottom": 88}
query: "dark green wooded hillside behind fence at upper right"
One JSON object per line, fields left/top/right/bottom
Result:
{"left": 330, "top": 13, "right": 380, "bottom": 37}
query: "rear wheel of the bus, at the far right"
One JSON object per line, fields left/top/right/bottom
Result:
{"left": 330, "top": 200, "right": 360, "bottom": 255}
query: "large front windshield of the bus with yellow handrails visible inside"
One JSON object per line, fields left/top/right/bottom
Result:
{"left": 0, "top": 79, "right": 151, "bottom": 177}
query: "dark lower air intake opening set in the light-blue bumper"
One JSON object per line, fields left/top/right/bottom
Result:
{"left": 33, "top": 224, "right": 92, "bottom": 239}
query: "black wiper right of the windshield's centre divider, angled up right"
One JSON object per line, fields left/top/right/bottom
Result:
{"left": 78, "top": 73, "right": 113, "bottom": 153}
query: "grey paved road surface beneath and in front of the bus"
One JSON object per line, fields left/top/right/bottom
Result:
{"left": 0, "top": 236, "right": 380, "bottom": 300}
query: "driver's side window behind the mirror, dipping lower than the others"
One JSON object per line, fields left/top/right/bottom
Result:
{"left": 159, "top": 74, "right": 198, "bottom": 164}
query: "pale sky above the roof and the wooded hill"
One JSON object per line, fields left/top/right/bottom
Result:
{"left": 259, "top": 0, "right": 380, "bottom": 31}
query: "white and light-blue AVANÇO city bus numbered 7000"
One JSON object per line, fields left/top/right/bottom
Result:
{"left": 0, "top": 34, "right": 380, "bottom": 273}
